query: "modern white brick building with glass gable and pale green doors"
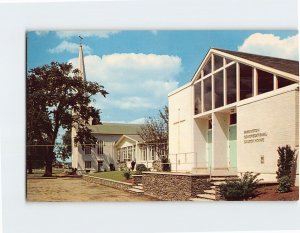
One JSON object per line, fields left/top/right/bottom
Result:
{"left": 168, "top": 48, "right": 299, "bottom": 184}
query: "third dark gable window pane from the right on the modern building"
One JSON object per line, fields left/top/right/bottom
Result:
{"left": 240, "top": 64, "right": 253, "bottom": 100}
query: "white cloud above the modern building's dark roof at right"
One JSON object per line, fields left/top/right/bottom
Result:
{"left": 238, "top": 33, "right": 299, "bottom": 60}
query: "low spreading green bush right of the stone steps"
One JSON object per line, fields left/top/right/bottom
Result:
{"left": 220, "top": 172, "right": 262, "bottom": 201}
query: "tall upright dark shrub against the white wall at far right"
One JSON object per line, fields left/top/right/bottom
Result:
{"left": 276, "top": 145, "right": 295, "bottom": 181}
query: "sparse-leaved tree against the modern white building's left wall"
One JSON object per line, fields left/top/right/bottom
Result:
{"left": 139, "top": 106, "right": 169, "bottom": 157}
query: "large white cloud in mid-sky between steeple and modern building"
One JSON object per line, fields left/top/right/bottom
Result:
{"left": 70, "top": 53, "right": 181, "bottom": 111}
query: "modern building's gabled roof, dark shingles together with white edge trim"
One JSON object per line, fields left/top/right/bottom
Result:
{"left": 191, "top": 48, "right": 299, "bottom": 83}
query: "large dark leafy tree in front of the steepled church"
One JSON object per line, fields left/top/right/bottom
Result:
{"left": 26, "top": 62, "right": 108, "bottom": 176}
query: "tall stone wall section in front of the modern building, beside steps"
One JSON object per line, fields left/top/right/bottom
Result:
{"left": 143, "top": 172, "right": 210, "bottom": 201}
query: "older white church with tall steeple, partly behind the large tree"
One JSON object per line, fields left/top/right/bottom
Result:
{"left": 71, "top": 45, "right": 158, "bottom": 174}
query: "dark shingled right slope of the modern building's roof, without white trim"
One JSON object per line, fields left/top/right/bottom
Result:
{"left": 213, "top": 48, "right": 299, "bottom": 76}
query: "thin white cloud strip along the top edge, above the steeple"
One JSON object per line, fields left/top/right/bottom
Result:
{"left": 56, "top": 30, "right": 120, "bottom": 39}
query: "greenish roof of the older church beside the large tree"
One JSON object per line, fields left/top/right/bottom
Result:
{"left": 88, "top": 123, "right": 142, "bottom": 135}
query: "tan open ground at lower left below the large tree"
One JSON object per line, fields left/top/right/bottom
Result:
{"left": 27, "top": 177, "right": 155, "bottom": 202}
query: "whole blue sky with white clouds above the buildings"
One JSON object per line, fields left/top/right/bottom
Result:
{"left": 27, "top": 30, "right": 299, "bottom": 123}
